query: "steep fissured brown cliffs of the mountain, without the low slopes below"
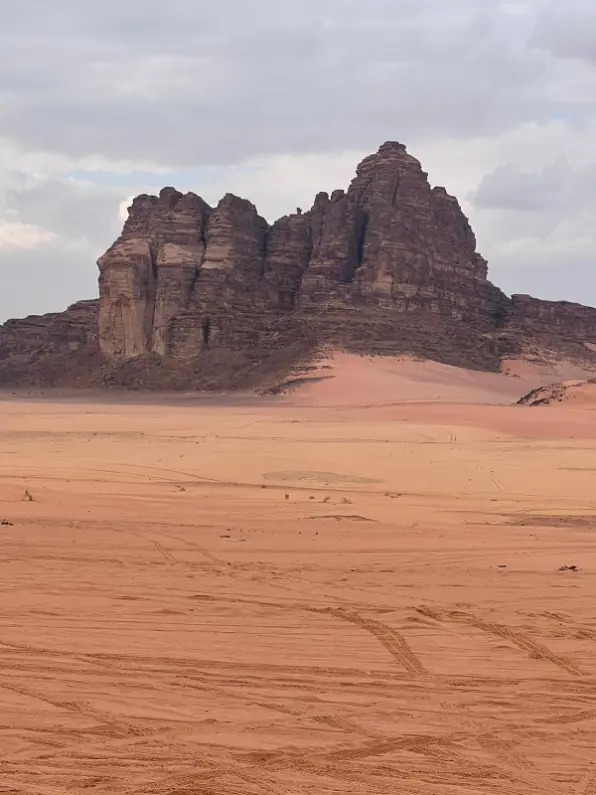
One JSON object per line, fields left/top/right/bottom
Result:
{"left": 99, "top": 143, "right": 505, "bottom": 364}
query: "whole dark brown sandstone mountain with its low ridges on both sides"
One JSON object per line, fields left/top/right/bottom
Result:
{"left": 0, "top": 142, "right": 596, "bottom": 389}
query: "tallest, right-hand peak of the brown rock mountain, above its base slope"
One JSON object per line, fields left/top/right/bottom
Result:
{"left": 349, "top": 143, "right": 504, "bottom": 326}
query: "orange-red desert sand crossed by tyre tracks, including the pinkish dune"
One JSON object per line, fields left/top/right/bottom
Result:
{"left": 0, "top": 357, "right": 596, "bottom": 795}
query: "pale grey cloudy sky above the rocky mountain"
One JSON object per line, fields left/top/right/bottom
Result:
{"left": 0, "top": 0, "right": 596, "bottom": 322}
